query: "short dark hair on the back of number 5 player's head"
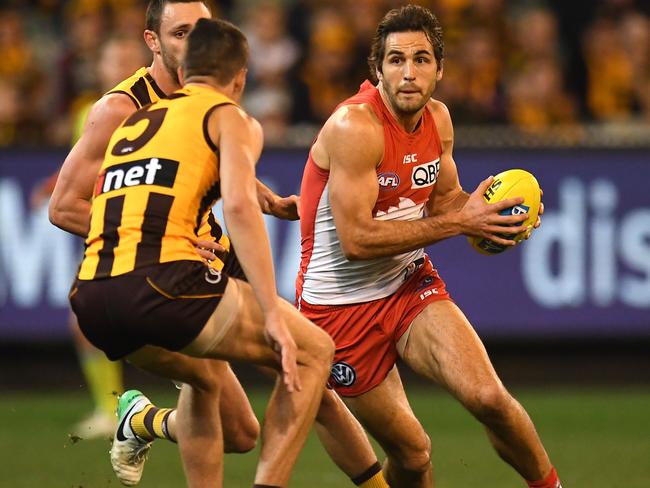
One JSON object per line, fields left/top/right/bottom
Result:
{"left": 183, "top": 19, "right": 248, "bottom": 85}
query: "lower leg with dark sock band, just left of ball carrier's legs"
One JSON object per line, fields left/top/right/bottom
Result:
{"left": 314, "top": 389, "right": 387, "bottom": 488}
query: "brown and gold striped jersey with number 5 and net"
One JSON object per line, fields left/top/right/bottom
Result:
{"left": 79, "top": 85, "right": 234, "bottom": 280}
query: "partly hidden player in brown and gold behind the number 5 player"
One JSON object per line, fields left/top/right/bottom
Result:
{"left": 50, "top": 0, "right": 386, "bottom": 488}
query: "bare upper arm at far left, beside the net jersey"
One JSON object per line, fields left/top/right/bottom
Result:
{"left": 49, "top": 93, "right": 136, "bottom": 237}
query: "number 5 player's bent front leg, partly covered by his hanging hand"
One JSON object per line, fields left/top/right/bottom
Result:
{"left": 183, "top": 279, "right": 334, "bottom": 486}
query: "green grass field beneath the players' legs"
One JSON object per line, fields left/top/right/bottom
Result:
{"left": 0, "top": 387, "right": 650, "bottom": 488}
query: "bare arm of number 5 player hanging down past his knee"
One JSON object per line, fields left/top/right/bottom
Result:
{"left": 208, "top": 105, "right": 300, "bottom": 391}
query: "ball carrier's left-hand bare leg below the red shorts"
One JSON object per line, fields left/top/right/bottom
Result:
{"left": 344, "top": 367, "right": 433, "bottom": 488}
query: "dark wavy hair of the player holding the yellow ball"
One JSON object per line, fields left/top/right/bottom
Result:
{"left": 368, "top": 5, "right": 445, "bottom": 81}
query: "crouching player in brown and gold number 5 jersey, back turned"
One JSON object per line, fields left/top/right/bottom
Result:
{"left": 70, "top": 19, "right": 334, "bottom": 487}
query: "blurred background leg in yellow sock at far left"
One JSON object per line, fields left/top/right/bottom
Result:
{"left": 69, "top": 312, "right": 123, "bottom": 439}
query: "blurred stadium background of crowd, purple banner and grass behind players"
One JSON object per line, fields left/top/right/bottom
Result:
{"left": 0, "top": 0, "right": 650, "bottom": 488}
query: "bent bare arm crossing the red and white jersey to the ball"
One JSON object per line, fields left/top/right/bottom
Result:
{"left": 320, "top": 106, "right": 521, "bottom": 260}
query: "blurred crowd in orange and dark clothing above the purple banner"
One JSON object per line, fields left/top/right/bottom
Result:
{"left": 0, "top": 0, "right": 650, "bottom": 146}
